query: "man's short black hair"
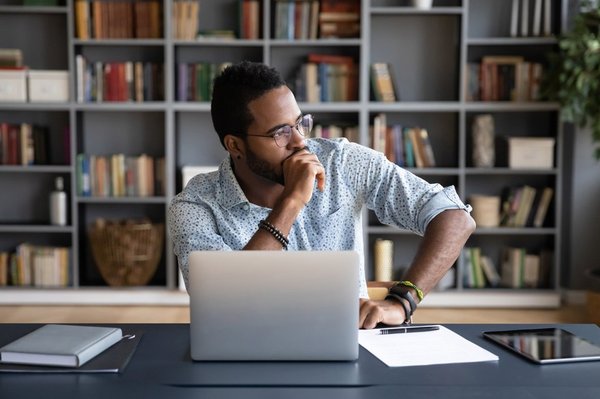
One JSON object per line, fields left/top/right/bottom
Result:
{"left": 210, "top": 61, "right": 286, "bottom": 147}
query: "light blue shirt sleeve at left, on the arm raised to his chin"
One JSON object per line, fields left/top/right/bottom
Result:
{"left": 167, "top": 194, "right": 231, "bottom": 288}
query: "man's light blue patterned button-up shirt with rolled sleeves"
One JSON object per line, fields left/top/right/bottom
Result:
{"left": 168, "top": 139, "right": 470, "bottom": 298}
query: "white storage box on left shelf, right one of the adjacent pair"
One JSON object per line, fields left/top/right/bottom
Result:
{"left": 29, "top": 70, "right": 69, "bottom": 102}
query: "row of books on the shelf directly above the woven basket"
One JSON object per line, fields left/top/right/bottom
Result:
{"left": 76, "top": 154, "right": 165, "bottom": 197}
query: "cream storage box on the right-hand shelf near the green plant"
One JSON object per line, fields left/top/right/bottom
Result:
{"left": 508, "top": 137, "right": 555, "bottom": 169}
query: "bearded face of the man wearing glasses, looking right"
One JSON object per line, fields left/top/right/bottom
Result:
{"left": 244, "top": 86, "right": 305, "bottom": 185}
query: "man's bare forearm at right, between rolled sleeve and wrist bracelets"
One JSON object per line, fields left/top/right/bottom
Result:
{"left": 404, "top": 209, "right": 475, "bottom": 301}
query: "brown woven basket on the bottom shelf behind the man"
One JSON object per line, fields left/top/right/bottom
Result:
{"left": 89, "top": 219, "right": 164, "bottom": 286}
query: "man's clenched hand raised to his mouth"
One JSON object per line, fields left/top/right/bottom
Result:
{"left": 283, "top": 148, "right": 325, "bottom": 205}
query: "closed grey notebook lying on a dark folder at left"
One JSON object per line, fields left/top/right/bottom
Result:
{"left": 0, "top": 324, "right": 123, "bottom": 367}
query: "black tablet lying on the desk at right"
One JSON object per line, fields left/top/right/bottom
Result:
{"left": 483, "top": 328, "right": 600, "bottom": 364}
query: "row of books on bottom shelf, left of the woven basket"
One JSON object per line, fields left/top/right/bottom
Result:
{"left": 0, "top": 243, "right": 71, "bottom": 287}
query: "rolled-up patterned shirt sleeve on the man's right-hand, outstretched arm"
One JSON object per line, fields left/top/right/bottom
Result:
{"left": 345, "top": 145, "right": 471, "bottom": 235}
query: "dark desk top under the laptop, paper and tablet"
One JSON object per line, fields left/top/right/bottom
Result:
{"left": 0, "top": 324, "right": 600, "bottom": 399}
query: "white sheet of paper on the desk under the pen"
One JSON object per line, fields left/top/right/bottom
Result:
{"left": 358, "top": 326, "right": 498, "bottom": 367}
